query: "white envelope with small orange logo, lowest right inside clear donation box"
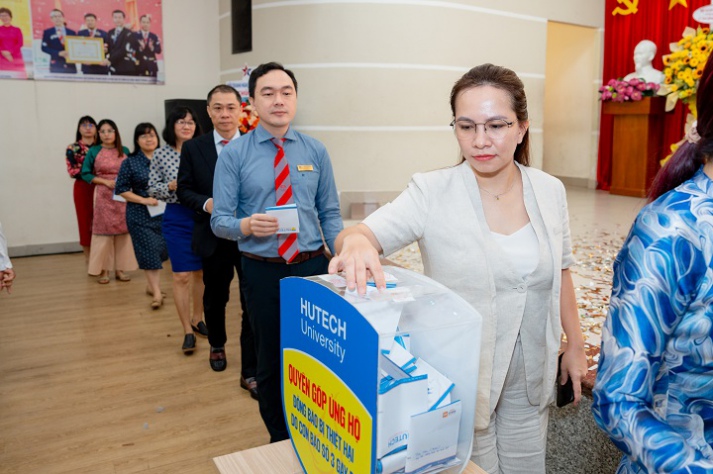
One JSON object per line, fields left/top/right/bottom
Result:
{"left": 406, "top": 400, "right": 461, "bottom": 474}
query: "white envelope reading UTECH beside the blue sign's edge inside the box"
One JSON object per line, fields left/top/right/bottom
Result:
{"left": 376, "top": 376, "right": 426, "bottom": 459}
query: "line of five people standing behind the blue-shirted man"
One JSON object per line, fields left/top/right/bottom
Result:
{"left": 65, "top": 90, "right": 257, "bottom": 398}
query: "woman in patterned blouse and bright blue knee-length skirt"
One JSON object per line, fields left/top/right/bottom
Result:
{"left": 149, "top": 107, "right": 208, "bottom": 354}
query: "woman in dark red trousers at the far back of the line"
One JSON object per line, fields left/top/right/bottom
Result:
{"left": 64, "top": 115, "right": 99, "bottom": 259}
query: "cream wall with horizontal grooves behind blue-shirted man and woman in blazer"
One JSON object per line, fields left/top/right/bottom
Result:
{"left": 220, "top": 0, "right": 604, "bottom": 202}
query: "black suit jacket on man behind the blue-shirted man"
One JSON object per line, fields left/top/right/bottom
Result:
{"left": 176, "top": 132, "right": 219, "bottom": 258}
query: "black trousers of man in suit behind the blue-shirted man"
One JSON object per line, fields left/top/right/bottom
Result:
{"left": 203, "top": 239, "right": 257, "bottom": 379}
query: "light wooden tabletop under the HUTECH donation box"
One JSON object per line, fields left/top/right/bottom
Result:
{"left": 213, "top": 440, "right": 486, "bottom": 474}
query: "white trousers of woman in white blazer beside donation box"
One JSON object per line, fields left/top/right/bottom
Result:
{"left": 471, "top": 336, "right": 549, "bottom": 474}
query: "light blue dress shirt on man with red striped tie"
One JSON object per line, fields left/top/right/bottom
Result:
{"left": 210, "top": 125, "right": 344, "bottom": 257}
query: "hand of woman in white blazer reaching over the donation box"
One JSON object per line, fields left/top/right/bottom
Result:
{"left": 329, "top": 224, "right": 386, "bottom": 295}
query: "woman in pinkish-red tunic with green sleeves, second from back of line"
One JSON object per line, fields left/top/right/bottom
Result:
{"left": 82, "top": 119, "right": 138, "bottom": 285}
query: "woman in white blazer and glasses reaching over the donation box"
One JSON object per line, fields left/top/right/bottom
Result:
{"left": 329, "top": 64, "right": 587, "bottom": 473}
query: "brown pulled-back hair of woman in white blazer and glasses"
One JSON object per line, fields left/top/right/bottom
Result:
{"left": 451, "top": 63, "right": 530, "bottom": 166}
